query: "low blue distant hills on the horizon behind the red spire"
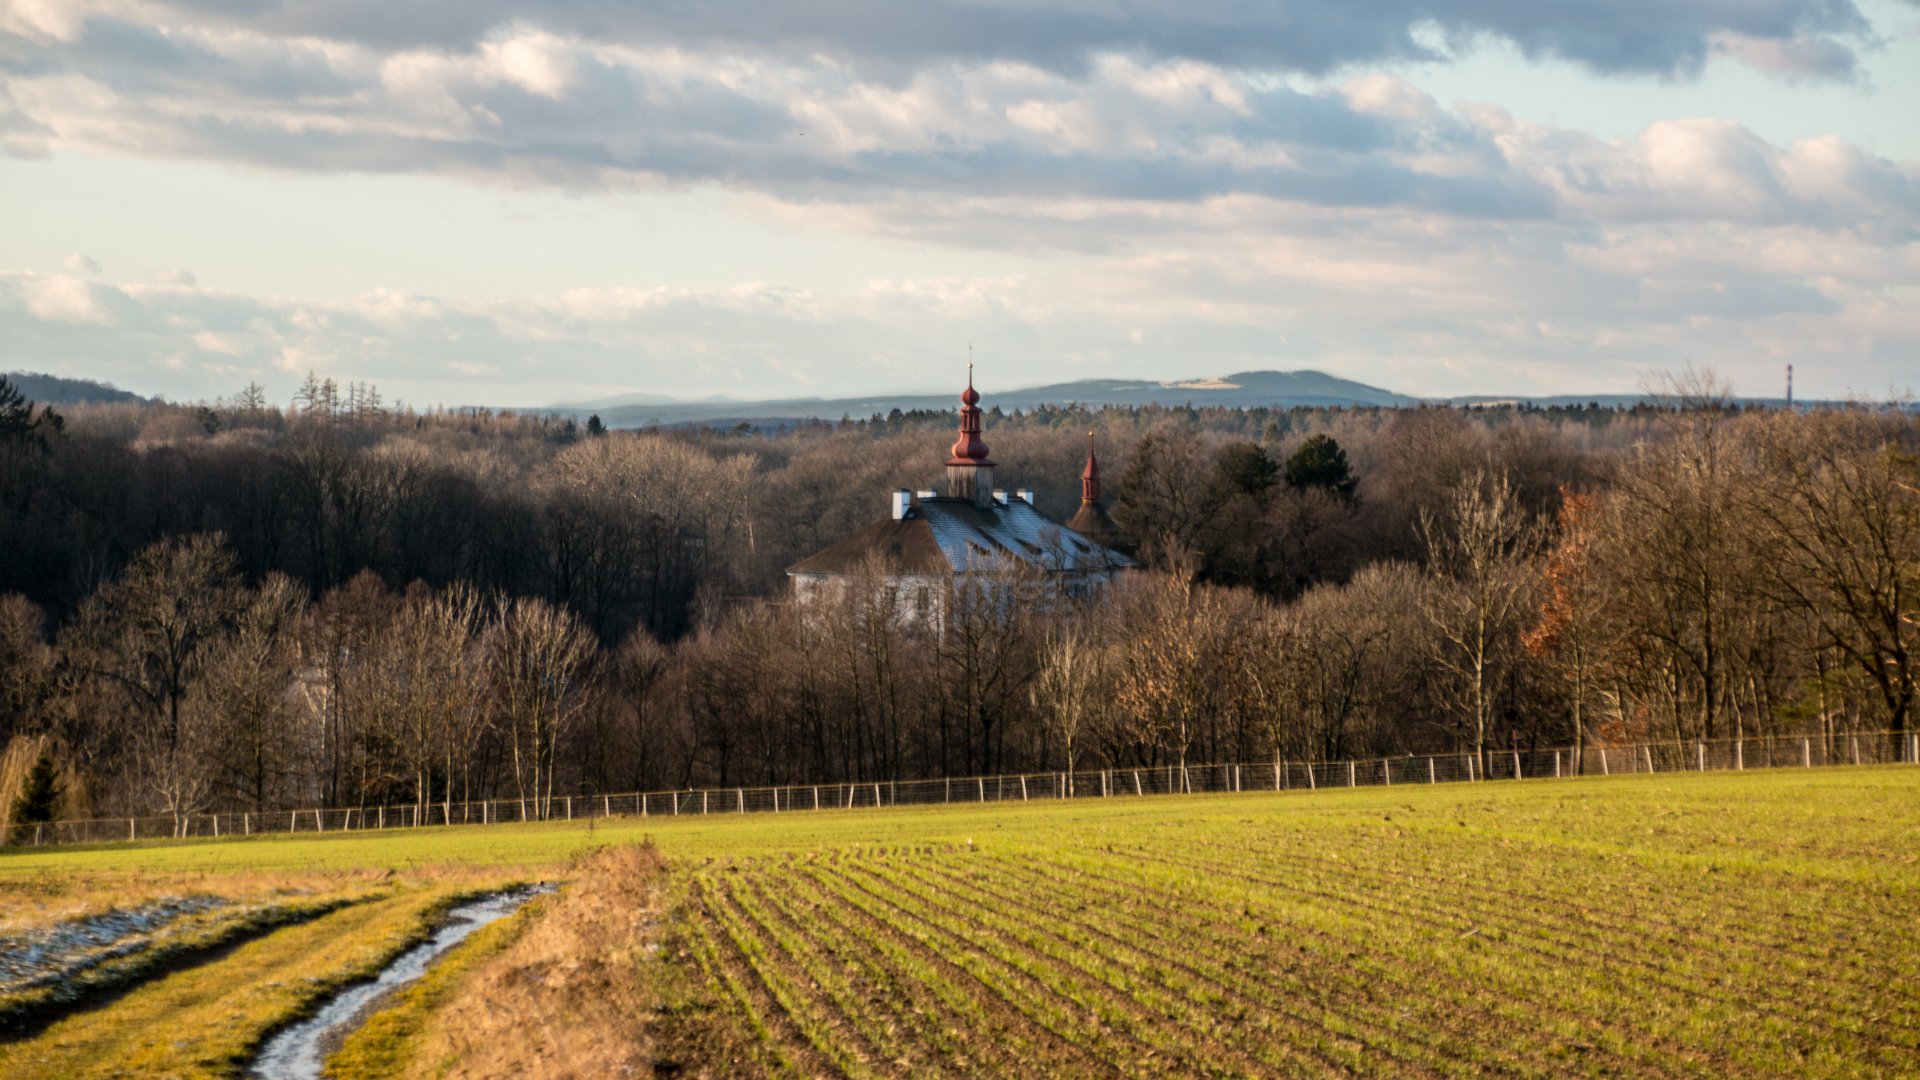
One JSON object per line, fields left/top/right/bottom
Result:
{"left": 549, "top": 371, "right": 1421, "bottom": 427}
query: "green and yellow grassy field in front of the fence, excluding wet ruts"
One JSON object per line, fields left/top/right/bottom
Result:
{"left": 0, "top": 767, "right": 1920, "bottom": 1076}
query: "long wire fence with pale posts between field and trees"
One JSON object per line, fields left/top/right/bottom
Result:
{"left": 13, "top": 732, "right": 1920, "bottom": 846}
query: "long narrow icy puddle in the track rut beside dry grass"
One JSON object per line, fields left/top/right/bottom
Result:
{"left": 248, "top": 886, "right": 553, "bottom": 1080}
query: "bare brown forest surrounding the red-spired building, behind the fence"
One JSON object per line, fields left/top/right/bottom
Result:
{"left": 0, "top": 373, "right": 1920, "bottom": 830}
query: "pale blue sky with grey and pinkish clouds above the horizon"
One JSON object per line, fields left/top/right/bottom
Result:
{"left": 0, "top": 0, "right": 1920, "bottom": 407}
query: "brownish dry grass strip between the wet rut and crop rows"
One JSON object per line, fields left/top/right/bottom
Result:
{"left": 328, "top": 846, "right": 664, "bottom": 1076}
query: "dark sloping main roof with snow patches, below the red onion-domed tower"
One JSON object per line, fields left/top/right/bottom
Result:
{"left": 787, "top": 498, "right": 1133, "bottom": 577}
